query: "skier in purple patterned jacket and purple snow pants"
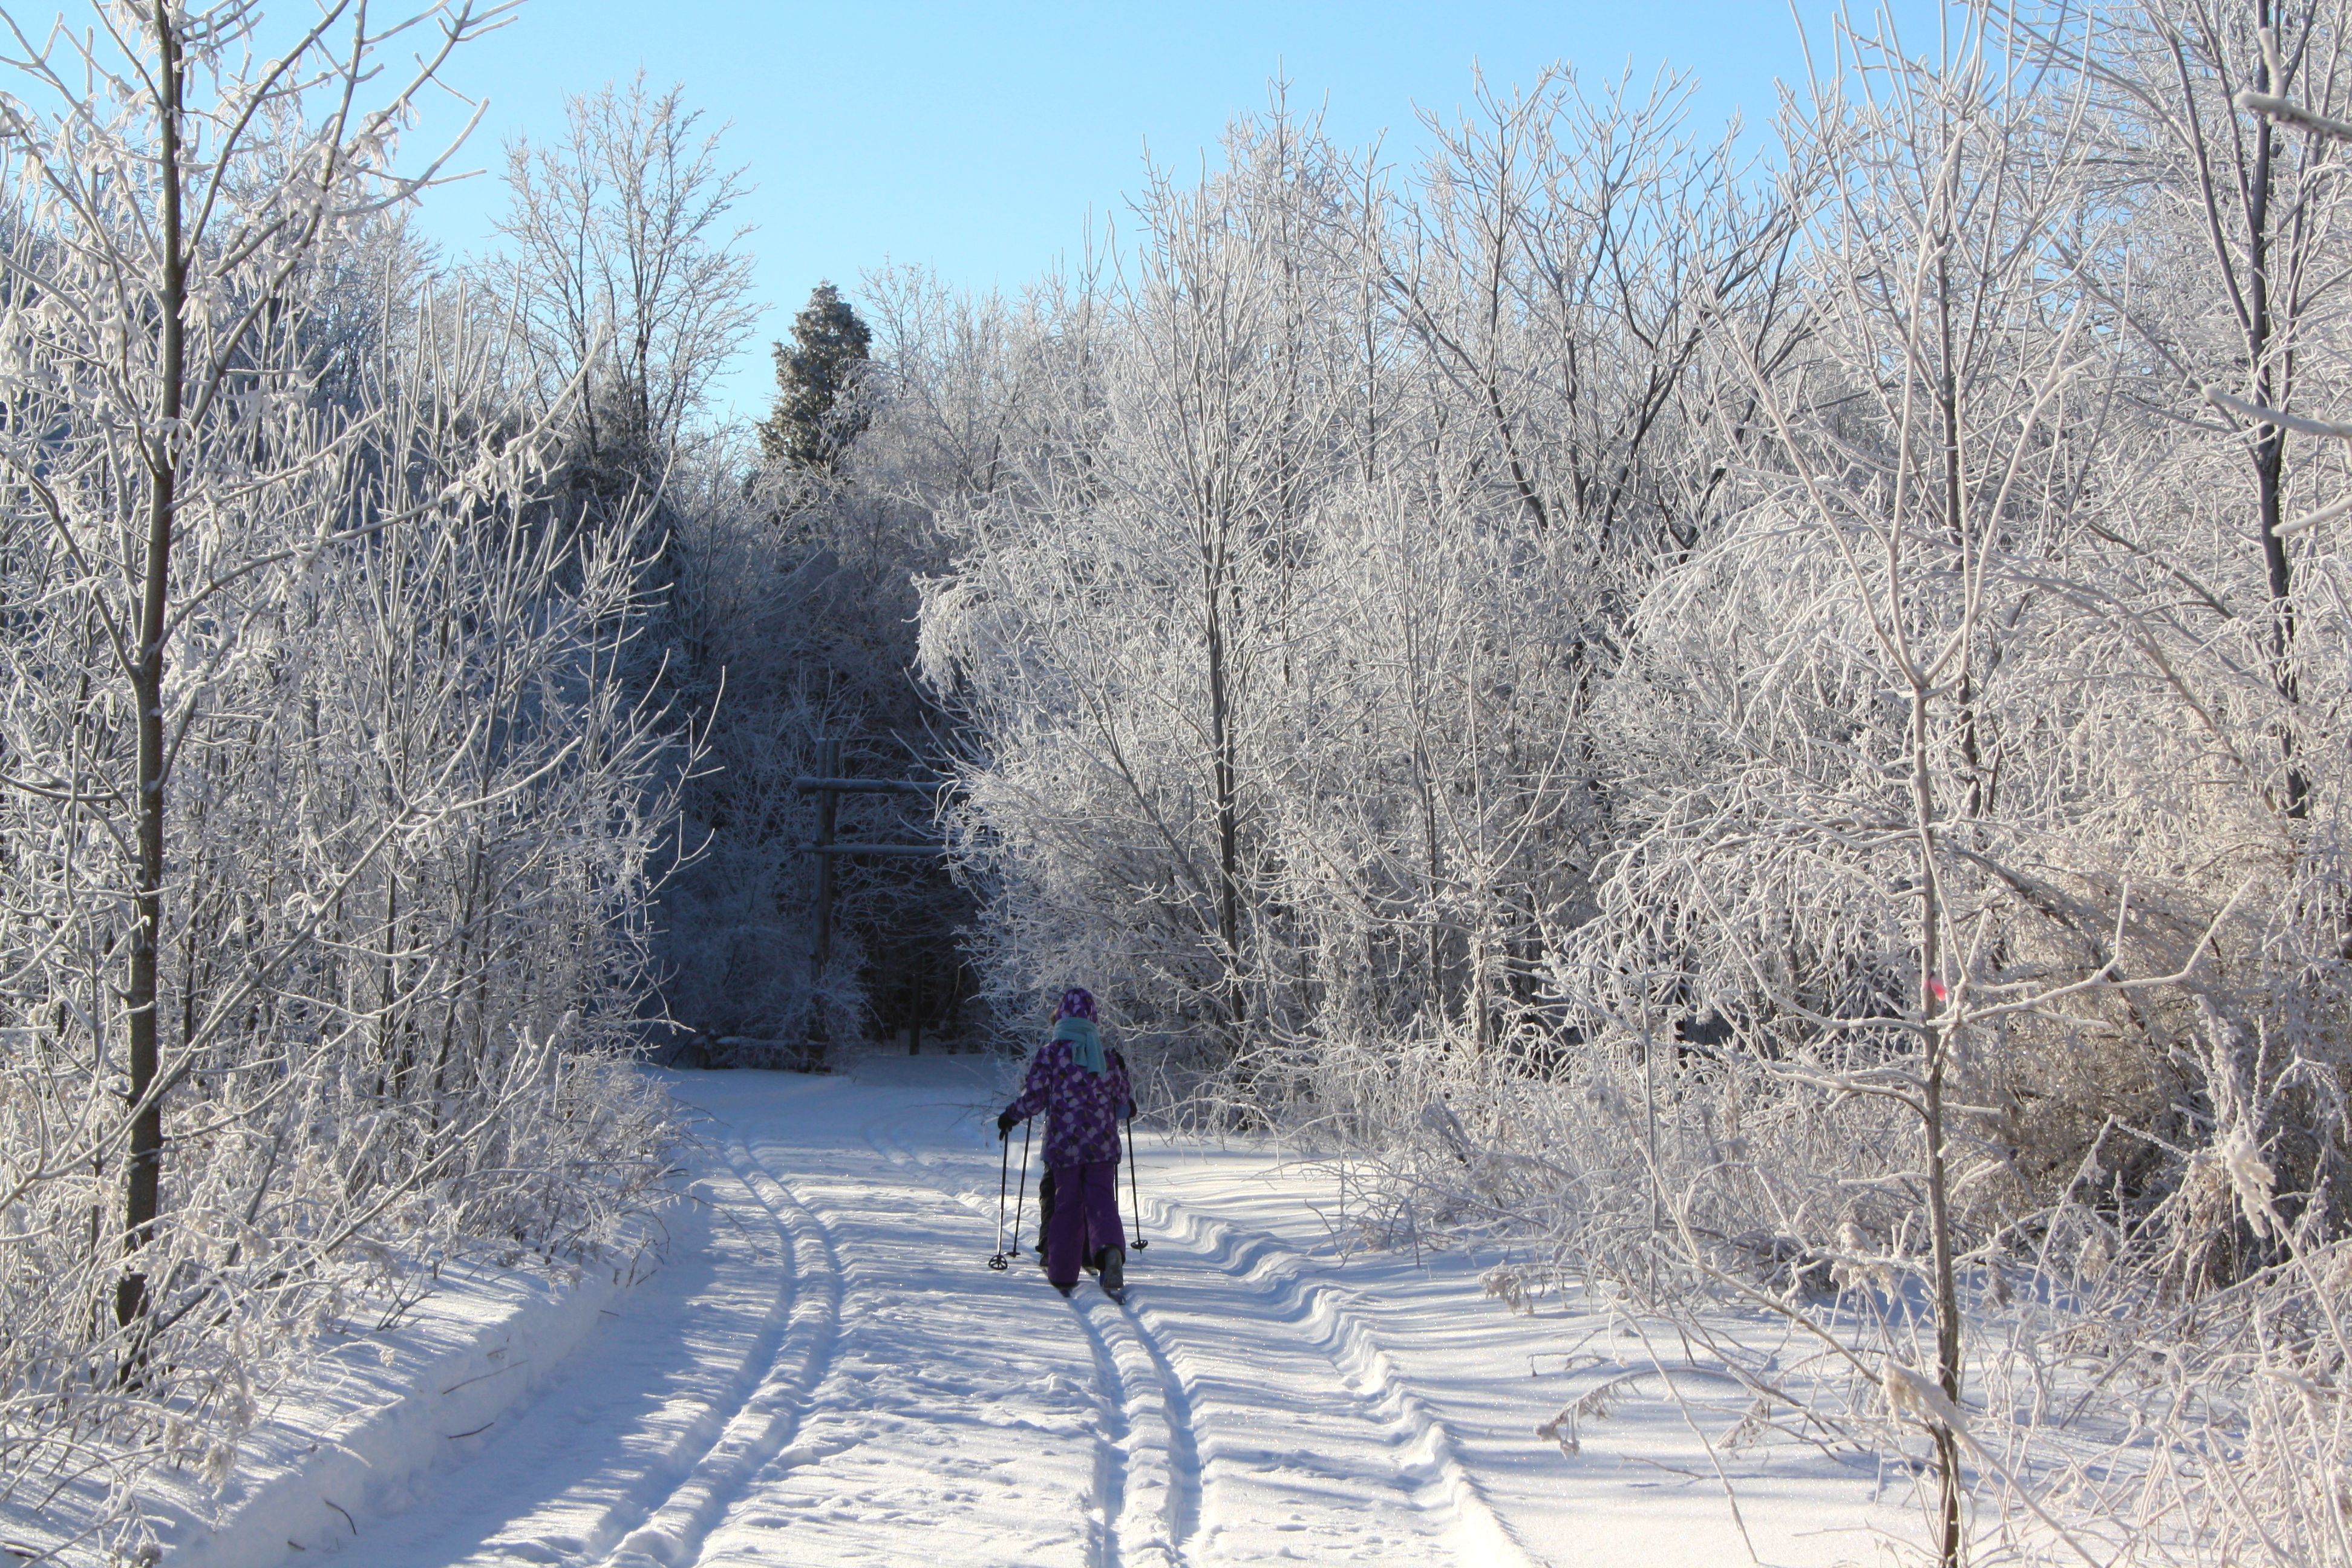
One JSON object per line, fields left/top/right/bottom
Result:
{"left": 998, "top": 985, "right": 1134, "bottom": 1295}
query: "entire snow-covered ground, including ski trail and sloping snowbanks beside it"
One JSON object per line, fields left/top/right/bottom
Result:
{"left": 142, "top": 1058, "right": 1912, "bottom": 1568}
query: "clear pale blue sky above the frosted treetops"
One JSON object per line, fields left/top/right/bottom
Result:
{"left": 404, "top": 0, "right": 1933, "bottom": 411}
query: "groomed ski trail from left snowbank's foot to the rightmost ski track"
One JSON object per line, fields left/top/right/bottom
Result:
{"left": 279, "top": 1065, "right": 1541, "bottom": 1568}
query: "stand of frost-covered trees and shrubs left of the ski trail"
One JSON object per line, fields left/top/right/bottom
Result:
{"left": 0, "top": 5, "right": 687, "bottom": 1554}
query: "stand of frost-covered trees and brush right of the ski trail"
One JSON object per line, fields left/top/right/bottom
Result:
{"left": 877, "top": 0, "right": 2352, "bottom": 1561}
